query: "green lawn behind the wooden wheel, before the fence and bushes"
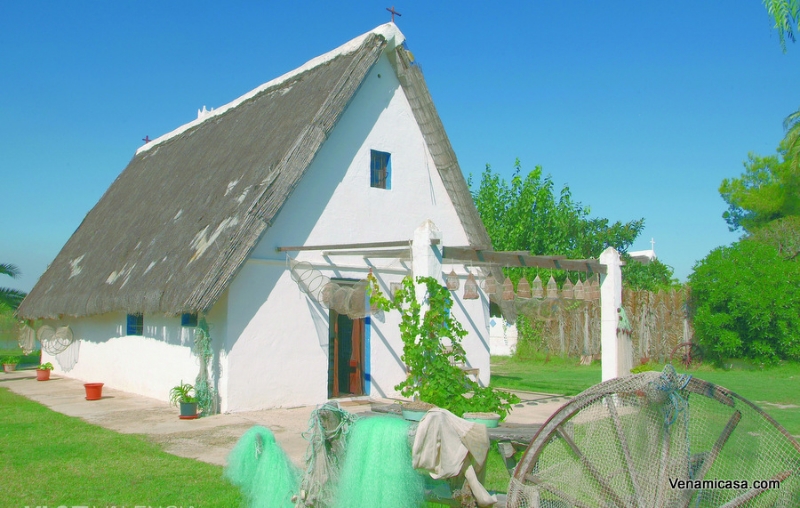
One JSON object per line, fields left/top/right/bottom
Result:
{"left": 491, "top": 357, "right": 800, "bottom": 436}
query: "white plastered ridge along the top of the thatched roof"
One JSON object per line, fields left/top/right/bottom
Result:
{"left": 136, "top": 22, "right": 405, "bottom": 155}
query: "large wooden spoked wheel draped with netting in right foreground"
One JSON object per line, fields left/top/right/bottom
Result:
{"left": 506, "top": 365, "right": 800, "bottom": 508}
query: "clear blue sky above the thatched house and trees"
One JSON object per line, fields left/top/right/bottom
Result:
{"left": 0, "top": 0, "right": 800, "bottom": 291}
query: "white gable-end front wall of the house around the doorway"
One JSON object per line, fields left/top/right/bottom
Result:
{"left": 222, "top": 52, "right": 489, "bottom": 411}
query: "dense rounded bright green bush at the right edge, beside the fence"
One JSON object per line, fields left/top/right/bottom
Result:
{"left": 689, "top": 240, "right": 800, "bottom": 364}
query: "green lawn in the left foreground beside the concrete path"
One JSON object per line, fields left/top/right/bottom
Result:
{"left": 0, "top": 388, "right": 241, "bottom": 508}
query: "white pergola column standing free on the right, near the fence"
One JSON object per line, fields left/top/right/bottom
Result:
{"left": 599, "top": 247, "right": 633, "bottom": 381}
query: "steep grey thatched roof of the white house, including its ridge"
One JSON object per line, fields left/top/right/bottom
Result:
{"left": 18, "top": 23, "right": 491, "bottom": 319}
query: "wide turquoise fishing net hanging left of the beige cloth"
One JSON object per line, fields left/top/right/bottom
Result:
{"left": 335, "top": 416, "right": 425, "bottom": 508}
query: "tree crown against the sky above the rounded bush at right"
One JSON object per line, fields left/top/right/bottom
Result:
{"left": 719, "top": 145, "right": 800, "bottom": 233}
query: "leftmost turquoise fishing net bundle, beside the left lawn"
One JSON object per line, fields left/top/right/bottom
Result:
{"left": 223, "top": 426, "right": 300, "bottom": 508}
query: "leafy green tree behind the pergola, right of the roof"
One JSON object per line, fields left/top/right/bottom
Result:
{"left": 469, "top": 159, "right": 644, "bottom": 259}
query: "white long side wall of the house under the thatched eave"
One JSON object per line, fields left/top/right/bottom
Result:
{"left": 42, "top": 297, "right": 227, "bottom": 400}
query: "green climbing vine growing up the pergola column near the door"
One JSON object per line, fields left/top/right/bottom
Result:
{"left": 368, "top": 274, "right": 519, "bottom": 418}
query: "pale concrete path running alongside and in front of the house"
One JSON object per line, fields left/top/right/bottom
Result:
{"left": 0, "top": 370, "right": 567, "bottom": 466}
